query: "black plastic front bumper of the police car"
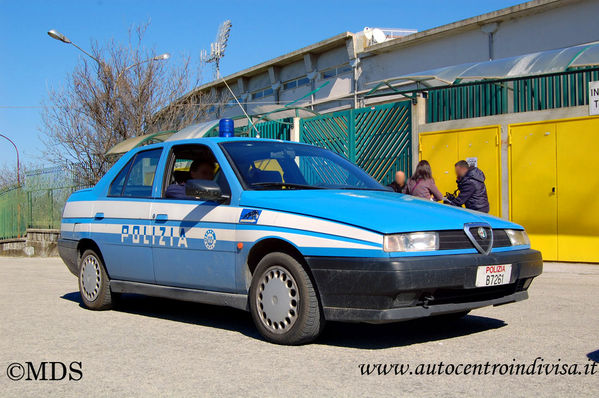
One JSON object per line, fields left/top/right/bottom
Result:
{"left": 306, "top": 249, "right": 543, "bottom": 323}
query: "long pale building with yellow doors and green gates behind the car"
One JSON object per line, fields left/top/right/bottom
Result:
{"left": 168, "top": 0, "right": 599, "bottom": 262}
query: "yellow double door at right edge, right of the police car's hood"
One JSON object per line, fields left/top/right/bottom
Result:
{"left": 509, "top": 117, "right": 599, "bottom": 262}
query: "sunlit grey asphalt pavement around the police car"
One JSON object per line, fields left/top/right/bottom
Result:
{"left": 0, "top": 257, "right": 599, "bottom": 397}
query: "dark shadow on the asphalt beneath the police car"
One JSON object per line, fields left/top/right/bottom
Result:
{"left": 61, "top": 292, "right": 507, "bottom": 350}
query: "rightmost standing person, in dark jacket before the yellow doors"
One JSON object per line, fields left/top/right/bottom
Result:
{"left": 447, "top": 160, "right": 489, "bottom": 213}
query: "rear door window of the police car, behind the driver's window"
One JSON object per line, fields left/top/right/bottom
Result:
{"left": 109, "top": 149, "right": 162, "bottom": 198}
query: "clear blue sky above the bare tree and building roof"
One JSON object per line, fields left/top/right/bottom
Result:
{"left": 0, "top": 0, "right": 522, "bottom": 166}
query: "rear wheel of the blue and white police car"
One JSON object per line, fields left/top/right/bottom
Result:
{"left": 79, "top": 250, "right": 113, "bottom": 311}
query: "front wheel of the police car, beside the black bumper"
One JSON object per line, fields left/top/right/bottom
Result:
{"left": 249, "top": 252, "right": 325, "bottom": 345}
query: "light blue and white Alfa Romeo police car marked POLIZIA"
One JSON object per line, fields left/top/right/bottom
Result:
{"left": 59, "top": 137, "right": 542, "bottom": 344}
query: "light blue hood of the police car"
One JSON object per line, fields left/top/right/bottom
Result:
{"left": 240, "top": 189, "right": 521, "bottom": 234}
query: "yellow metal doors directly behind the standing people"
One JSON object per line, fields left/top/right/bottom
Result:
{"left": 419, "top": 126, "right": 501, "bottom": 216}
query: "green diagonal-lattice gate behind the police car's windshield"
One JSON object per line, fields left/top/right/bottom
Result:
{"left": 300, "top": 101, "right": 412, "bottom": 184}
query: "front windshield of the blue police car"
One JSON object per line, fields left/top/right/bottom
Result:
{"left": 221, "top": 141, "right": 386, "bottom": 191}
